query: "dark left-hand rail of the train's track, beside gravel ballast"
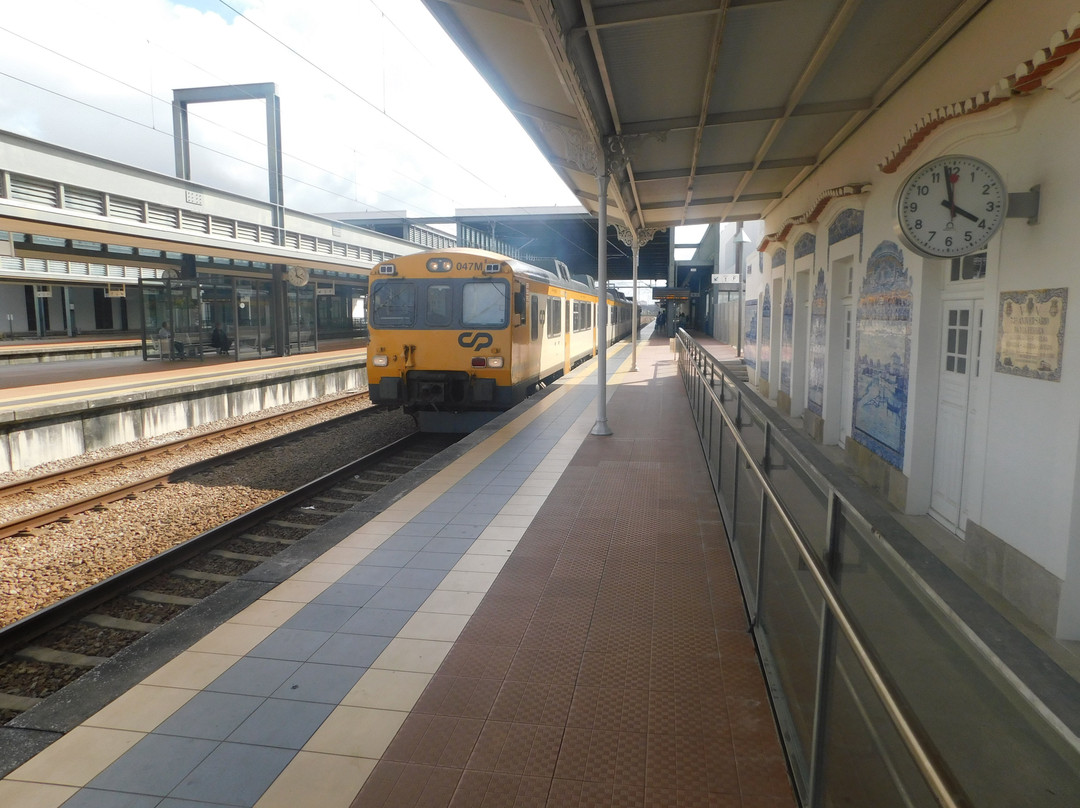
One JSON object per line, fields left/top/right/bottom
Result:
{"left": 0, "top": 433, "right": 422, "bottom": 655}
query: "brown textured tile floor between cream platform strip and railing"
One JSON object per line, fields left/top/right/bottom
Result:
{"left": 353, "top": 340, "right": 795, "bottom": 808}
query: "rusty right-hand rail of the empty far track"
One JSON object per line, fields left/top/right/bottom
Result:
{"left": 0, "top": 399, "right": 378, "bottom": 539}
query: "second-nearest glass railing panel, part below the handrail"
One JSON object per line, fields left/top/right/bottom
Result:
{"left": 758, "top": 504, "right": 822, "bottom": 764}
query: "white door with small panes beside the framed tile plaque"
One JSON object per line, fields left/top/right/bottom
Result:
{"left": 930, "top": 300, "right": 975, "bottom": 529}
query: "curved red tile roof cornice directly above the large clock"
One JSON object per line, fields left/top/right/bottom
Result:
{"left": 878, "top": 12, "right": 1080, "bottom": 174}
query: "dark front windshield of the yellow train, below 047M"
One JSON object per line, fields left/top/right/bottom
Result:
{"left": 370, "top": 278, "right": 510, "bottom": 329}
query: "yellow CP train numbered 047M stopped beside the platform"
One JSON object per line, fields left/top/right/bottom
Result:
{"left": 367, "top": 250, "right": 632, "bottom": 432}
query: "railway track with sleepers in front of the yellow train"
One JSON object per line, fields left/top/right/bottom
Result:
{"left": 0, "top": 425, "right": 455, "bottom": 724}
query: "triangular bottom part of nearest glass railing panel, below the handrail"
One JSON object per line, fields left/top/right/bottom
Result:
{"left": 822, "top": 633, "right": 939, "bottom": 808}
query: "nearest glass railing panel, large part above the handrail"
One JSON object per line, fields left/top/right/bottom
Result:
{"left": 838, "top": 505, "right": 1080, "bottom": 808}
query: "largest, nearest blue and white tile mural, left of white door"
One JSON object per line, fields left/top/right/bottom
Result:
{"left": 851, "top": 241, "right": 912, "bottom": 469}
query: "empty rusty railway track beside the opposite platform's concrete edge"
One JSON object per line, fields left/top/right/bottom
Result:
{"left": 0, "top": 391, "right": 368, "bottom": 539}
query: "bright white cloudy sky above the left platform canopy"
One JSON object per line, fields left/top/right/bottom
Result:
{"left": 0, "top": 0, "right": 576, "bottom": 216}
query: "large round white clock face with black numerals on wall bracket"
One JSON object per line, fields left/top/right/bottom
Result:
{"left": 896, "top": 154, "right": 1009, "bottom": 258}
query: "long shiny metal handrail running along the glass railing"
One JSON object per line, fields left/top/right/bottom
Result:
{"left": 676, "top": 329, "right": 971, "bottom": 808}
